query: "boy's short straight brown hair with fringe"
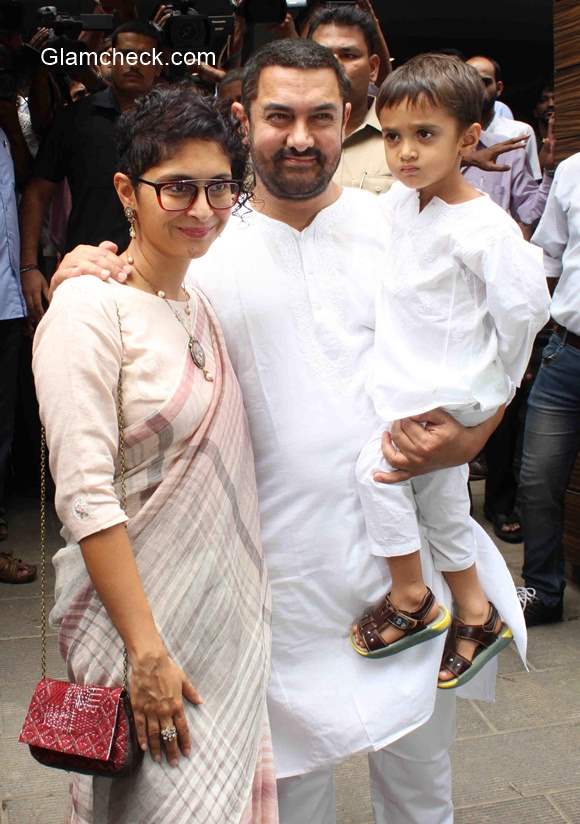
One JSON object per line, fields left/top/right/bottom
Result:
{"left": 377, "top": 54, "right": 485, "bottom": 127}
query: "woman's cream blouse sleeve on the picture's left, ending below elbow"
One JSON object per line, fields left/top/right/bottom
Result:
{"left": 33, "top": 277, "right": 127, "bottom": 541}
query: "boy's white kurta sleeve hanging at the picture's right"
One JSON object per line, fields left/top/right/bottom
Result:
{"left": 462, "top": 216, "right": 550, "bottom": 386}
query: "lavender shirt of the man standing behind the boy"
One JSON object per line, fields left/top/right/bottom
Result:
{"left": 463, "top": 135, "right": 552, "bottom": 225}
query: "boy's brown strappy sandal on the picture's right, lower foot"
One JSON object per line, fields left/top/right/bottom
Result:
{"left": 437, "top": 601, "right": 513, "bottom": 690}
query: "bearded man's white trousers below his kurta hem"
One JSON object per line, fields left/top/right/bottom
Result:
{"left": 278, "top": 691, "right": 455, "bottom": 824}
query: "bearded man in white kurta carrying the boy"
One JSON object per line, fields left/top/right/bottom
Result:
{"left": 56, "top": 40, "right": 523, "bottom": 824}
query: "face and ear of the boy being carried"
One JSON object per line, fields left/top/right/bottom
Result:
{"left": 379, "top": 100, "right": 480, "bottom": 190}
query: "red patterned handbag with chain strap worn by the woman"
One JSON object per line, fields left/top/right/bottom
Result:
{"left": 18, "top": 338, "right": 143, "bottom": 778}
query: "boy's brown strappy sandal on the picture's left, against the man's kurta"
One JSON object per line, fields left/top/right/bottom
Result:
{"left": 350, "top": 587, "right": 451, "bottom": 658}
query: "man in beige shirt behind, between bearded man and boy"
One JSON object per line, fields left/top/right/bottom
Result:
{"left": 308, "top": 6, "right": 393, "bottom": 194}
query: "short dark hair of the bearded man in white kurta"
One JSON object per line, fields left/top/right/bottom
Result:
{"left": 242, "top": 38, "right": 350, "bottom": 112}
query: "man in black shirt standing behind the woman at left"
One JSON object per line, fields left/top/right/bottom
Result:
{"left": 20, "top": 22, "right": 160, "bottom": 322}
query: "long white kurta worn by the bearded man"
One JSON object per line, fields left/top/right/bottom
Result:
{"left": 190, "top": 189, "right": 525, "bottom": 778}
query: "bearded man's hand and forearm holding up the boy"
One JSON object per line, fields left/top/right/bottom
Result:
{"left": 374, "top": 407, "right": 504, "bottom": 484}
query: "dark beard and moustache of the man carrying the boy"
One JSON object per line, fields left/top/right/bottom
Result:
{"left": 252, "top": 142, "right": 342, "bottom": 200}
